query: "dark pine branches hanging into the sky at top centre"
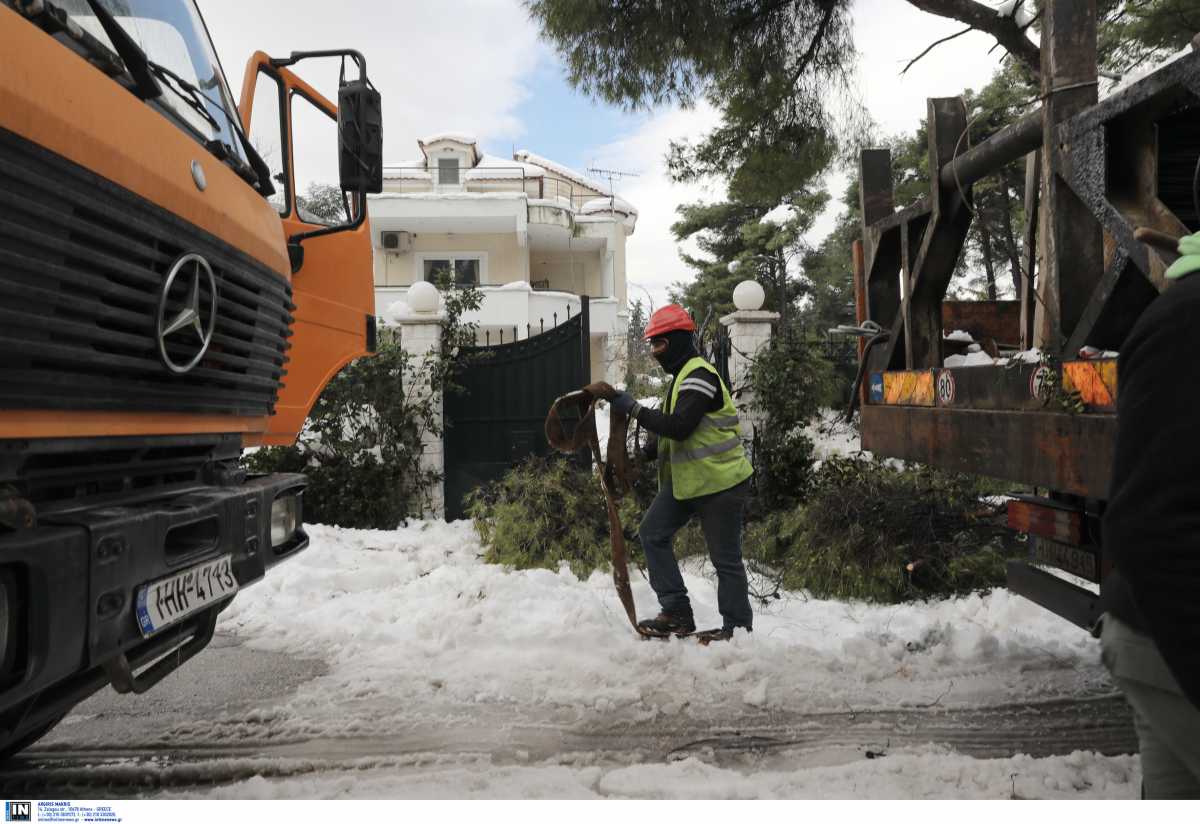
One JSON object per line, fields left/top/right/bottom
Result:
{"left": 527, "top": 0, "right": 854, "bottom": 193}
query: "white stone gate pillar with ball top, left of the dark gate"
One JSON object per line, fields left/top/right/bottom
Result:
{"left": 389, "top": 281, "right": 445, "bottom": 518}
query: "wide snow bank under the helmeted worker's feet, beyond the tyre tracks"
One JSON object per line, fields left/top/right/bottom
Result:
{"left": 222, "top": 522, "right": 1110, "bottom": 736}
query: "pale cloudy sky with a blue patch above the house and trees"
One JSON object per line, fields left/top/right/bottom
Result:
{"left": 199, "top": 0, "right": 1017, "bottom": 305}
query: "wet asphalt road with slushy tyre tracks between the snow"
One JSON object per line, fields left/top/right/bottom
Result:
{"left": 0, "top": 634, "right": 1138, "bottom": 799}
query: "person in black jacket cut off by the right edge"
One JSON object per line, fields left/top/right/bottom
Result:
{"left": 1100, "top": 233, "right": 1200, "bottom": 799}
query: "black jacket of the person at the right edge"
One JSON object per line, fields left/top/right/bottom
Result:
{"left": 1103, "top": 275, "right": 1200, "bottom": 706}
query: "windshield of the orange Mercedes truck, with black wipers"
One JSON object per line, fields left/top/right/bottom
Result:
{"left": 55, "top": 0, "right": 248, "bottom": 168}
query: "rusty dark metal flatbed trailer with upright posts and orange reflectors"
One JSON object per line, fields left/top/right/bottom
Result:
{"left": 854, "top": 0, "right": 1200, "bottom": 628}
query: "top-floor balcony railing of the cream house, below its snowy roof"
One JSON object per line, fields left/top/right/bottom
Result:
{"left": 384, "top": 166, "right": 607, "bottom": 211}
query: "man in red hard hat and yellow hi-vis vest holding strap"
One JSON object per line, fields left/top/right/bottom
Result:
{"left": 612, "top": 303, "right": 754, "bottom": 643}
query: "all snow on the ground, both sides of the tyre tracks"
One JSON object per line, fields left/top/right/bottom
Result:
{"left": 189, "top": 513, "right": 1140, "bottom": 798}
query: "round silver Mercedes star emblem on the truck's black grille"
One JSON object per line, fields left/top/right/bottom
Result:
{"left": 157, "top": 254, "right": 217, "bottom": 374}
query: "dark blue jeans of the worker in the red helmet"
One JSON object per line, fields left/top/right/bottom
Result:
{"left": 637, "top": 480, "right": 754, "bottom": 630}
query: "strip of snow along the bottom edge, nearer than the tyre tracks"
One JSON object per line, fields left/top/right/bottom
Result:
{"left": 170, "top": 746, "right": 1140, "bottom": 800}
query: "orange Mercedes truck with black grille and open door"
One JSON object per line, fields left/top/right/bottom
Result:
{"left": 0, "top": 0, "right": 382, "bottom": 756}
